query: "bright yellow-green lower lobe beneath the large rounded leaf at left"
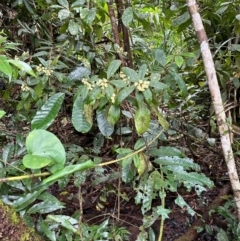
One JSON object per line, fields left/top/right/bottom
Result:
{"left": 23, "top": 154, "right": 53, "bottom": 169}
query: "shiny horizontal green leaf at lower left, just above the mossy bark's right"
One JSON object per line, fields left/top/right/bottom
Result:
{"left": 27, "top": 200, "right": 65, "bottom": 214}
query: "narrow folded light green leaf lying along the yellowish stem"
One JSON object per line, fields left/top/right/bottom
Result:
{"left": 43, "top": 160, "right": 95, "bottom": 183}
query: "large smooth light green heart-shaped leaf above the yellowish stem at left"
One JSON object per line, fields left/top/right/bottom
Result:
{"left": 23, "top": 129, "right": 66, "bottom": 173}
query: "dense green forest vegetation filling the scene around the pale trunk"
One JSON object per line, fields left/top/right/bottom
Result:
{"left": 0, "top": 0, "right": 240, "bottom": 241}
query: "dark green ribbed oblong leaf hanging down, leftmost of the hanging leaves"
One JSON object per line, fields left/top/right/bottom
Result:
{"left": 72, "top": 97, "right": 92, "bottom": 133}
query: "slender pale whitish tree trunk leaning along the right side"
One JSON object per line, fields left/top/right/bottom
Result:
{"left": 186, "top": 0, "right": 240, "bottom": 220}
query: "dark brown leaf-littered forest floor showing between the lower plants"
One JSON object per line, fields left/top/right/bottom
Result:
{"left": 0, "top": 109, "right": 234, "bottom": 241}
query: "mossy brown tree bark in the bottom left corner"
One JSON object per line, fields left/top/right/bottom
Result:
{"left": 0, "top": 200, "right": 44, "bottom": 241}
